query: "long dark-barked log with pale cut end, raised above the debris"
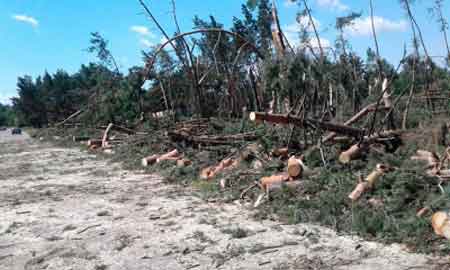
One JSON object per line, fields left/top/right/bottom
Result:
{"left": 249, "top": 112, "right": 365, "bottom": 137}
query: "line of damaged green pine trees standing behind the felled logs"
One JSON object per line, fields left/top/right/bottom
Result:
{"left": 6, "top": 0, "right": 450, "bottom": 127}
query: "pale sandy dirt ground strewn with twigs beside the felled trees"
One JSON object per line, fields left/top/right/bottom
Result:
{"left": 0, "top": 131, "right": 448, "bottom": 270}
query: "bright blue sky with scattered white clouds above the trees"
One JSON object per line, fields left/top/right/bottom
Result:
{"left": 0, "top": 0, "right": 450, "bottom": 103}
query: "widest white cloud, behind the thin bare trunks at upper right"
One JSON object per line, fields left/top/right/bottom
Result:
{"left": 345, "top": 16, "right": 408, "bottom": 36}
